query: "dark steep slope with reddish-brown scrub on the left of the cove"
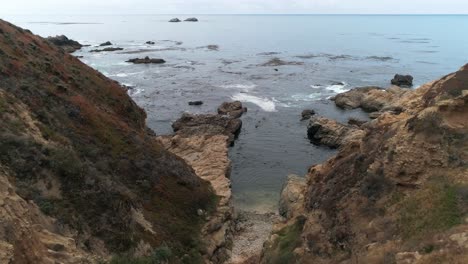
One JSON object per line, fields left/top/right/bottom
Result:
{"left": 0, "top": 20, "right": 217, "bottom": 263}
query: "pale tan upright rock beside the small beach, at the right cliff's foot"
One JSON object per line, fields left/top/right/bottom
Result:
{"left": 278, "top": 175, "right": 307, "bottom": 219}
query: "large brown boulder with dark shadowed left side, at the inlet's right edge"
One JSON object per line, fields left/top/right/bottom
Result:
{"left": 307, "top": 117, "right": 364, "bottom": 148}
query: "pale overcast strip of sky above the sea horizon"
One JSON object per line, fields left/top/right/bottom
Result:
{"left": 0, "top": 0, "right": 468, "bottom": 14}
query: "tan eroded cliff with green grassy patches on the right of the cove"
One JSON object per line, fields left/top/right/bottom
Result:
{"left": 262, "top": 65, "right": 468, "bottom": 263}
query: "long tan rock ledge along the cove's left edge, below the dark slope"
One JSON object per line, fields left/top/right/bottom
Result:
{"left": 159, "top": 103, "right": 247, "bottom": 263}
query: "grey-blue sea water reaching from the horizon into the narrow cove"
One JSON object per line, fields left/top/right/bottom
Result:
{"left": 4, "top": 15, "right": 468, "bottom": 212}
